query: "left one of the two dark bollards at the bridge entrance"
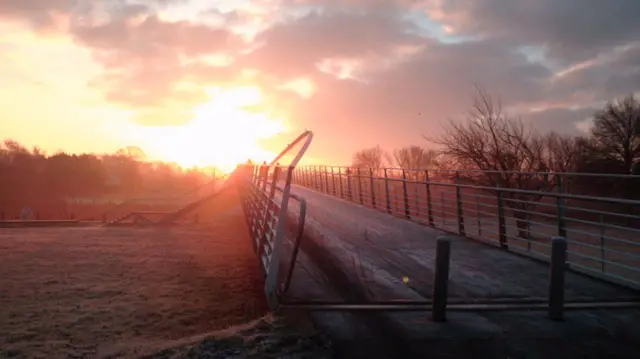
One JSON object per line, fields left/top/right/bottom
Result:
{"left": 431, "top": 236, "right": 451, "bottom": 322}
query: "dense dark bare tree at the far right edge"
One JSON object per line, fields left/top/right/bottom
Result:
{"left": 591, "top": 95, "right": 640, "bottom": 173}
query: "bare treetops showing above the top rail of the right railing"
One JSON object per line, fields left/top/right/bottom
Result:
{"left": 353, "top": 88, "right": 640, "bottom": 197}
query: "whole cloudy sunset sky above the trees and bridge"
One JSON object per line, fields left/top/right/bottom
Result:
{"left": 0, "top": 0, "right": 640, "bottom": 172}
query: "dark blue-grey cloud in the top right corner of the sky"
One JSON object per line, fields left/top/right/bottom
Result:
{"left": 414, "top": 0, "right": 640, "bottom": 65}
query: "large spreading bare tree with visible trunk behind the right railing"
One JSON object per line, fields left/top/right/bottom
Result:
{"left": 425, "top": 87, "right": 554, "bottom": 243}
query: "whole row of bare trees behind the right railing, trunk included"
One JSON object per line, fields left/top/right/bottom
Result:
{"left": 352, "top": 87, "right": 640, "bottom": 237}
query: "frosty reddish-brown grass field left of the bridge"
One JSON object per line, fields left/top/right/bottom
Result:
{"left": 0, "top": 198, "right": 266, "bottom": 358}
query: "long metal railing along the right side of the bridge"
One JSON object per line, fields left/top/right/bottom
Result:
{"left": 293, "top": 166, "right": 640, "bottom": 289}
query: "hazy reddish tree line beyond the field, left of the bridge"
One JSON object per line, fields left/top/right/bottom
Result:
{"left": 0, "top": 139, "right": 211, "bottom": 216}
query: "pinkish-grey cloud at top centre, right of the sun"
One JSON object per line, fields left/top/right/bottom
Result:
{"left": 241, "top": 7, "right": 421, "bottom": 76}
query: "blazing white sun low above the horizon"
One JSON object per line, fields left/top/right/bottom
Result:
{"left": 146, "top": 87, "right": 287, "bottom": 173}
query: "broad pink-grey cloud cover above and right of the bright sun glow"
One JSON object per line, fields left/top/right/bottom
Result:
{"left": 0, "top": 0, "right": 640, "bottom": 161}
